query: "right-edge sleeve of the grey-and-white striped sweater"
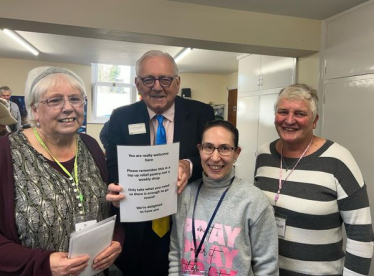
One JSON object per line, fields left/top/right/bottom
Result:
{"left": 331, "top": 146, "right": 373, "bottom": 276}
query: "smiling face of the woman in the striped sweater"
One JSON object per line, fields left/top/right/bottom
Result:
{"left": 274, "top": 99, "right": 318, "bottom": 147}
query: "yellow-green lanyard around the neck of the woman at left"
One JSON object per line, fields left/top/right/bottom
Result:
{"left": 33, "top": 127, "right": 84, "bottom": 215}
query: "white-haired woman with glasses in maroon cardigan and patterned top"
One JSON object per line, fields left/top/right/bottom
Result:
{"left": 0, "top": 67, "right": 123, "bottom": 276}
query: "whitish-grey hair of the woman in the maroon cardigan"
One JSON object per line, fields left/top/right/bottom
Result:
{"left": 25, "top": 66, "right": 87, "bottom": 126}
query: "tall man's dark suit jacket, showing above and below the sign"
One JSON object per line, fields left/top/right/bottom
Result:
{"left": 107, "top": 97, "right": 214, "bottom": 276}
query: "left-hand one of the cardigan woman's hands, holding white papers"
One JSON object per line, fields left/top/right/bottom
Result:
{"left": 49, "top": 252, "right": 90, "bottom": 276}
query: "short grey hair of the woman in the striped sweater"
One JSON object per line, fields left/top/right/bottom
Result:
{"left": 274, "top": 83, "right": 318, "bottom": 120}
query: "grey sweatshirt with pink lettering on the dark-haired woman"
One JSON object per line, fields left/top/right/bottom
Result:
{"left": 169, "top": 169, "right": 279, "bottom": 276}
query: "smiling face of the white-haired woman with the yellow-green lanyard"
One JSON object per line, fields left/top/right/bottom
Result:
{"left": 33, "top": 82, "right": 84, "bottom": 137}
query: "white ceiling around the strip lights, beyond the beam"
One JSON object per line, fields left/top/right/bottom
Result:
{"left": 0, "top": 31, "right": 242, "bottom": 75}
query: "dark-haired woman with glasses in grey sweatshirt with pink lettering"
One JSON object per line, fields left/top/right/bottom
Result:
{"left": 169, "top": 120, "right": 278, "bottom": 276}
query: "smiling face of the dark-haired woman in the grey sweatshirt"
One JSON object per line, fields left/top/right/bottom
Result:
{"left": 200, "top": 126, "right": 240, "bottom": 179}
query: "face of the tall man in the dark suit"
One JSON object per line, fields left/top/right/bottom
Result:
{"left": 135, "top": 56, "right": 180, "bottom": 114}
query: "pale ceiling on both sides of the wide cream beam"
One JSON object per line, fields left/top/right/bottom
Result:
{"left": 0, "top": 0, "right": 367, "bottom": 75}
